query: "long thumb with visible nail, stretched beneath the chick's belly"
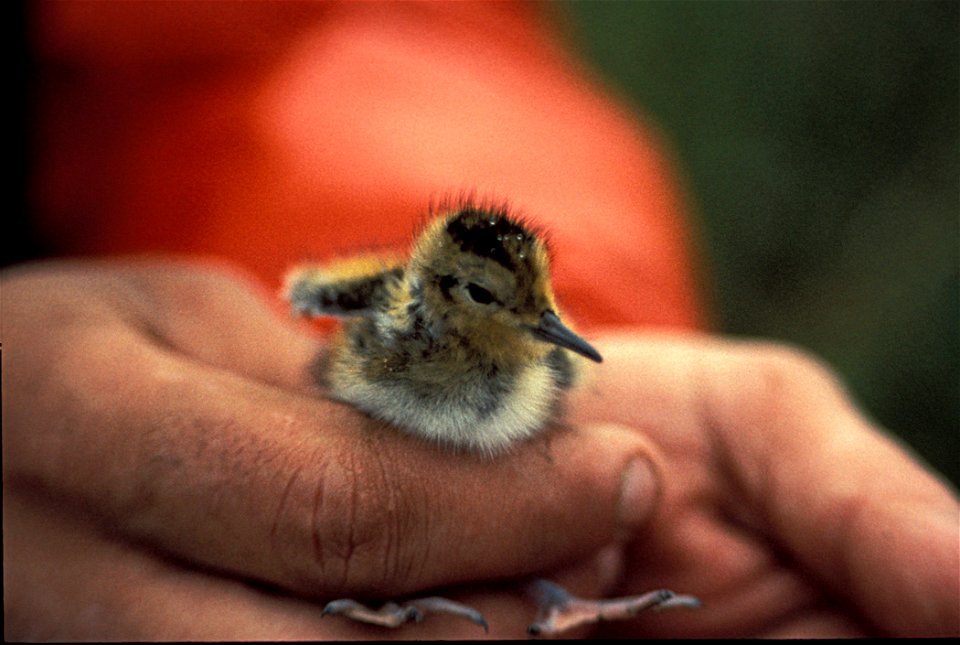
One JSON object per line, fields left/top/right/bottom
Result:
{"left": 4, "top": 270, "right": 656, "bottom": 597}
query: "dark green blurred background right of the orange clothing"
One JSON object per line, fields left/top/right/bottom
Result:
{"left": 557, "top": 2, "right": 960, "bottom": 485}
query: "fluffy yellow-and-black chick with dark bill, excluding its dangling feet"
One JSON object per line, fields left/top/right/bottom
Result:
{"left": 287, "top": 206, "right": 602, "bottom": 454}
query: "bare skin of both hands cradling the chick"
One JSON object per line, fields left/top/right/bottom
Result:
{"left": 2, "top": 261, "right": 960, "bottom": 640}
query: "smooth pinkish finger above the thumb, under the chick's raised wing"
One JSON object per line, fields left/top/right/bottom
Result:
{"left": 52, "top": 258, "right": 320, "bottom": 388}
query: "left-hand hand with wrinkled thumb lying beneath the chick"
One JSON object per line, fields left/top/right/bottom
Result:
{"left": 2, "top": 261, "right": 655, "bottom": 640}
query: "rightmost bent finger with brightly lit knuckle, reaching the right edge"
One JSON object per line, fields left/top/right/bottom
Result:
{"left": 704, "top": 340, "right": 960, "bottom": 636}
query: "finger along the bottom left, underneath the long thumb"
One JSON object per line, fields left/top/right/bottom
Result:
{"left": 4, "top": 494, "right": 531, "bottom": 641}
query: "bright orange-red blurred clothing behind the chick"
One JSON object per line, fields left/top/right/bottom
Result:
{"left": 34, "top": 2, "right": 701, "bottom": 327}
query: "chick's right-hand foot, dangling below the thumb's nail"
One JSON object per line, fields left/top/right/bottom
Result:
{"left": 526, "top": 578, "right": 701, "bottom": 636}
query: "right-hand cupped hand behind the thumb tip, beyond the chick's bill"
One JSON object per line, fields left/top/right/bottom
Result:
{"left": 569, "top": 334, "right": 960, "bottom": 637}
